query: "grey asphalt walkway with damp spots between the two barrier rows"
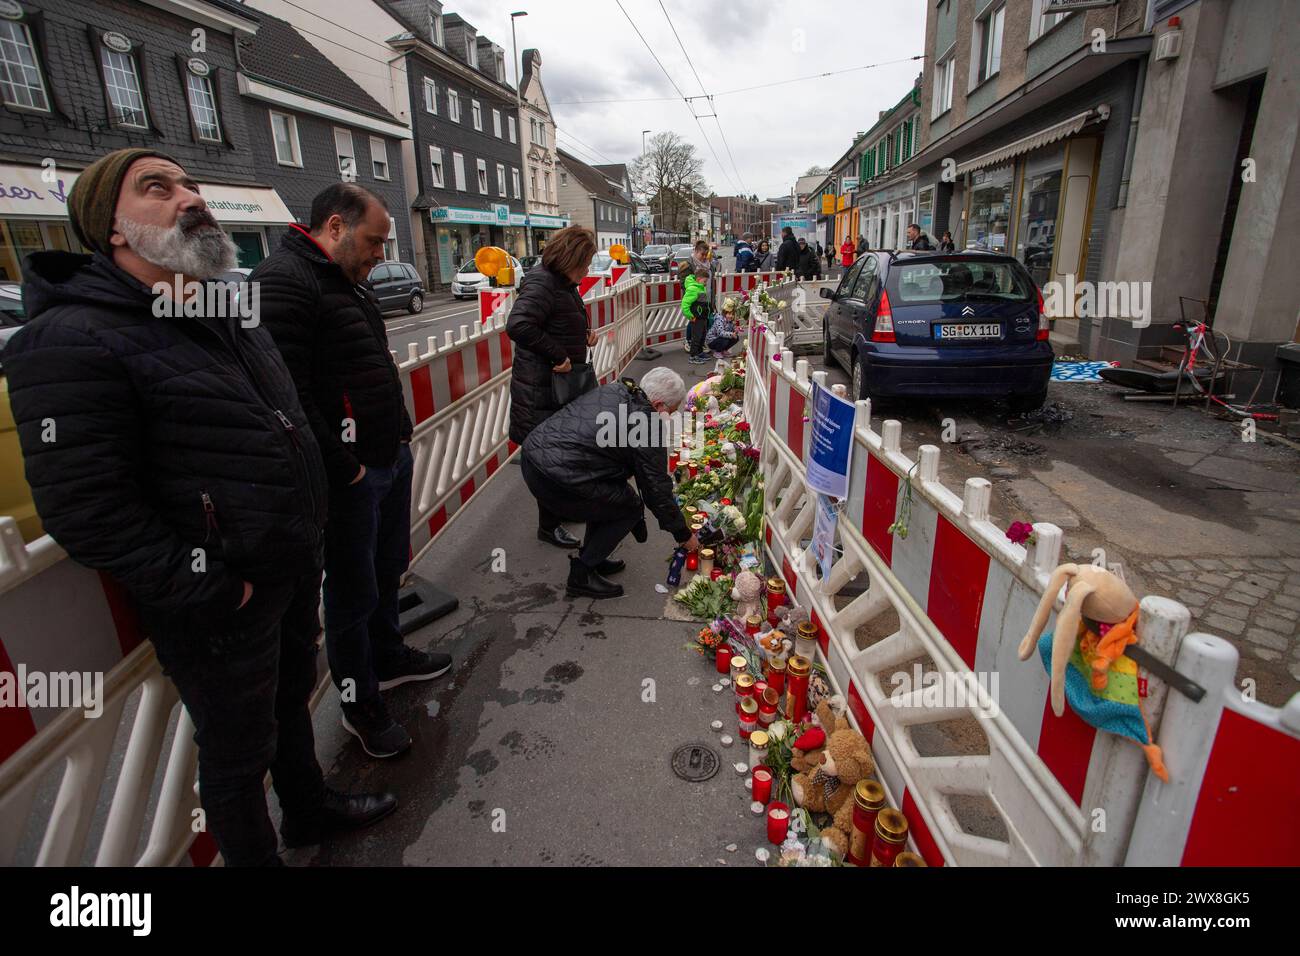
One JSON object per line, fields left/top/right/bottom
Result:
{"left": 285, "top": 346, "right": 770, "bottom": 866}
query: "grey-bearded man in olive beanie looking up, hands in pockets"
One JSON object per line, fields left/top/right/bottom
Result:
{"left": 4, "top": 150, "right": 397, "bottom": 866}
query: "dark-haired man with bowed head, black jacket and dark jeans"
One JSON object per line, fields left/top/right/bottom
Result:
{"left": 250, "top": 182, "right": 451, "bottom": 757}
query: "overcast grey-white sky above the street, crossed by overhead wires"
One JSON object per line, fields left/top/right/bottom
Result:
{"left": 443, "top": 0, "right": 930, "bottom": 198}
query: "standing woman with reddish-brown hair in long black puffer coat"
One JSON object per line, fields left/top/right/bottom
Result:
{"left": 506, "top": 226, "right": 595, "bottom": 548}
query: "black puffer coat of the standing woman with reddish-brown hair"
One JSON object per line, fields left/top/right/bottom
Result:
{"left": 506, "top": 265, "right": 588, "bottom": 445}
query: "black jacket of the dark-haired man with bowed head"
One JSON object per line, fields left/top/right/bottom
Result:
{"left": 248, "top": 228, "right": 411, "bottom": 486}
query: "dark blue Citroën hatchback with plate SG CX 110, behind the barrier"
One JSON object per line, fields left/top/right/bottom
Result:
{"left": 822, "top": 251, "right": 1053, "bottom": 411}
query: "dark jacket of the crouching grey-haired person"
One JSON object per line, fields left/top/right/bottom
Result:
{"left": 524, "top": 378, "right": 690, "bottom": 541}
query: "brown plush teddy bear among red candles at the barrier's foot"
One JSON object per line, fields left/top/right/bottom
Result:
{"left": 790, "top": 701, "right": 876, "bottom": 857}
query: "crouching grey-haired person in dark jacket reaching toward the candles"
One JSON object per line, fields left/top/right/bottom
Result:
{"left": 523, "top": 368, "right": 699, "bottom": 598}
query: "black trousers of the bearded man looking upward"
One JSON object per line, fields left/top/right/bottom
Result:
{"left": 150, "top": 571, "right": 325, "bottom": 866}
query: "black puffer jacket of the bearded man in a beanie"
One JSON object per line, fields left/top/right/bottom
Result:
{"left": 4, "top": 252, "right": 326, "bottom": 620}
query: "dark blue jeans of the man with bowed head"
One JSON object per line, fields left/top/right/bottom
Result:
{"left": 325, "top": 445, "right": 413, "bottom": 709}
